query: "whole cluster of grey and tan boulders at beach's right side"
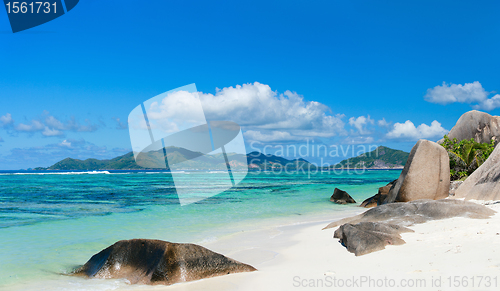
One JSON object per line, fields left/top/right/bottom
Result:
{"left": 325, "top": 110, "right": 500, "bottom": 256}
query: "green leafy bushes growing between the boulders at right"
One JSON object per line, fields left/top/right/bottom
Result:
{"left": 441, "top": 135, "right": 495, "bottom": 181}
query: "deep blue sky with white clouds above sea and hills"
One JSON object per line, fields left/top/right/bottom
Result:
{"left": 0, "top": 0, "right": 500, "bottom": 170}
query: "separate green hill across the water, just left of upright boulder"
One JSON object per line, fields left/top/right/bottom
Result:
{"left": 335, "top": 146, "right": 410, "bottom": 169}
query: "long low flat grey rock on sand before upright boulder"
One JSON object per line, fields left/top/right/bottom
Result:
{"left": 324, "top": 199, "right": 496, "bottom": 229}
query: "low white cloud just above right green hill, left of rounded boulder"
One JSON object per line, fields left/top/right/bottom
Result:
{"left": 386, "top": 120, "right": 448, "bottom": 140}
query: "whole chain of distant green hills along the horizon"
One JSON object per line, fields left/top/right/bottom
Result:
{"left": 35, "top": 146, "right": 409, "bottom": 171}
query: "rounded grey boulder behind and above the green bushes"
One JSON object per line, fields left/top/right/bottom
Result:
{"left": 438, "top": 110, "right": 500, "bottom": 143}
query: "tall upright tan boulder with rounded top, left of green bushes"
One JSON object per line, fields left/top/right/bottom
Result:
{"left": 384, "top": 139, "right": 450, "bottom": 203}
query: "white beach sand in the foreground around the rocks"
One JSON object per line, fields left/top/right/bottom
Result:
{"left": 127, "top": 203, "right": 500, "bottom": 290}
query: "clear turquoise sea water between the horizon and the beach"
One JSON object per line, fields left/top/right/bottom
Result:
{"left": 0, "top": 170, "right": 400, "bottom": 290}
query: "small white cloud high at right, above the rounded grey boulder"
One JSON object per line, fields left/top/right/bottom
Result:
{"left": 424, "top": 81, "right": 489, "bottom": 105}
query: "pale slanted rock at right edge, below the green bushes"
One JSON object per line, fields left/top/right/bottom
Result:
{"left": 455, "top": 147, "right": 500, "bottom": 200}
